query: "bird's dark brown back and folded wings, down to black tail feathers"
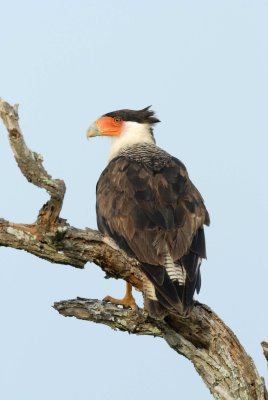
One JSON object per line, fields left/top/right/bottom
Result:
{"left": 97, "top": 157, "right": 209, "bottom": 316}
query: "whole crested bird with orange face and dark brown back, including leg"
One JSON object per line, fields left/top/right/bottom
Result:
{"left": 87, "top": 106, "right": 210, "bottom": 319}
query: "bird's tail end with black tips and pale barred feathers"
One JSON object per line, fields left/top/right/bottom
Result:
{"left": 142, "top": 228, "right": 206, "bottom": 319}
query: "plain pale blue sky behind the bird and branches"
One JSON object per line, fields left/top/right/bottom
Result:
{"left": 0, "top": 0, "right": 268, "bottom": 400}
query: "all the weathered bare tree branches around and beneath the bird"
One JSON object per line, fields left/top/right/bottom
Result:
{"left": 0, "top": 100, "right": 268, "bottom": 400}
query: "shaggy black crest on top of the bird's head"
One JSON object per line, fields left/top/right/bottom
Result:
{"left": 103, "top": 106, "right": 160, "bottom": 125}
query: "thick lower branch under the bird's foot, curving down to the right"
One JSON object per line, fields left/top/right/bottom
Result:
{"left": 54, "top": 298, "right": 268, "bottom": 400}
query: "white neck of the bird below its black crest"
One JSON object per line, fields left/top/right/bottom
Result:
{"left": 108, "top": 121, "right": 154, "bottom": 161}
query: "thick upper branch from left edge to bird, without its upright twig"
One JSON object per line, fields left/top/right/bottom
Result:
{"left": 0, "top": 219, "right": 143, "bottom": 290}
